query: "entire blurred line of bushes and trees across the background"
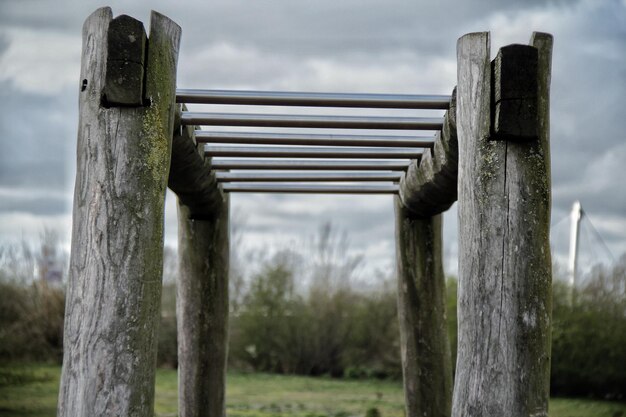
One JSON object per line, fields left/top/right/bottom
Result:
{"left": 0, "top": 225, "right": 626, "bottom": 399}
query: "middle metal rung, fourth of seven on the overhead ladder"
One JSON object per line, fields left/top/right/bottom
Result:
{"left": 204, "top": 145, "right": 422, "bottom": 159}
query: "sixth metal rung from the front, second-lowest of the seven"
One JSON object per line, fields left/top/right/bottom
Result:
{"left": 215, "top": 171, "right": 403, "bottom": 182}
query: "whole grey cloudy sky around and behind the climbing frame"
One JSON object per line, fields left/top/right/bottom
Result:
{"left": 0, "top": 0, "right": 626, "bottom": 280}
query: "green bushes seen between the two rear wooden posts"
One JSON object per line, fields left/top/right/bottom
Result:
{"left": 230, "top": 257, "right": 401, "bottom": 378}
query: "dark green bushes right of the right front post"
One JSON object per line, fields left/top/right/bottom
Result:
{"left": 551, "top": 257, "right": 626, "bottom": 399}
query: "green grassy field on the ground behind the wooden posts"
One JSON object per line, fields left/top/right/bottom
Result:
{"left": 0, "top": 365, "right": 626, "bottom": 417}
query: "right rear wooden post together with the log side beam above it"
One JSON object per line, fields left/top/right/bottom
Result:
{"left": 395, "top": 92, "right": 458, "bottom": 417}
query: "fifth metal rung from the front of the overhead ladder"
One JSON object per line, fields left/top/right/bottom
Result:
{"left": 211, "top": 159, "right": 411, "bottom": 171}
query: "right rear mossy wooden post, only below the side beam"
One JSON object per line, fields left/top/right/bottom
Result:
{"left": 394, "top": 197, "right": 452, "bottom": 417}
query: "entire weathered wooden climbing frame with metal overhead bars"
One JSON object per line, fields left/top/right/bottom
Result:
{"left": 58, "top": 8, "right": 552, "bottom": 417}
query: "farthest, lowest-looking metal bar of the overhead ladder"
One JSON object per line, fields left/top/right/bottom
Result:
{"left": 222, "top": 183, "right": 399, "bottom": 194}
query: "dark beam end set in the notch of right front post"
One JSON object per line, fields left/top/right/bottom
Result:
{"left": 491, "top": 45, "right": 538, "bottom": 141}
